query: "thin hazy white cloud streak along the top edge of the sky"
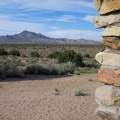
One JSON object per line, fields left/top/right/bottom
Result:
{"left": 0, "top": 0, "right": 95, "bottom": 13}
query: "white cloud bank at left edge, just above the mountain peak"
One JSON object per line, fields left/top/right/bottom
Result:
{"left": 0, "top": 14, "right": 44, "bottom": 35}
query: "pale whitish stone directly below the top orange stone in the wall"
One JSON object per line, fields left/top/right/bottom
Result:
{"left": 94, "top": 13, "right": 120, "bottom": 28}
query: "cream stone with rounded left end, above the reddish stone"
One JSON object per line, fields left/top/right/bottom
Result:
{"left": 95, "top": 52, "right": 120, "bottom": 67}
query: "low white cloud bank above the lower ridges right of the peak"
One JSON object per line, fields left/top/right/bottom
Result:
{"left": 44, "top": 29, "right": 102, "bottom": 40}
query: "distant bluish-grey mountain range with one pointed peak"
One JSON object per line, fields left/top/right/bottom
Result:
{"left": 0, "top": 30, "right": 100, "bottom": 44}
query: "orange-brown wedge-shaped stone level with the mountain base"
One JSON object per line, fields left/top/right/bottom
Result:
{"left": 101, "top": 39, "right": 120, "bottom": 50}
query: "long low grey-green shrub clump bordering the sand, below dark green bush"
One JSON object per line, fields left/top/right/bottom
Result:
{"left": 26, "top": 62, "right": 75, "bottom": 75}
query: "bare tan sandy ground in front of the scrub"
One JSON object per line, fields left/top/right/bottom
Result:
{"left": 0, "top": 74, "right": 103, "bottom": 120}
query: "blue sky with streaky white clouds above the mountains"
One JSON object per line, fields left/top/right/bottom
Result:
{"left": 0, "top": 0, "right": 102, "bottom": 40}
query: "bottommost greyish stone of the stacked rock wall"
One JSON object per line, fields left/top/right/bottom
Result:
{"left": 96, "top": 106, "right": 120, "bottom": 120}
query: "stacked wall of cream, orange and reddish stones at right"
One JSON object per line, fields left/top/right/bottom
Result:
{"left": 94, "top": 0, "right": 120, "bottom": 120}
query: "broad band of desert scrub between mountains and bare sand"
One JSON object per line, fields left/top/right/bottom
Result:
{"left": 0, "top": 44, "right": 103, "bottom": 79}
